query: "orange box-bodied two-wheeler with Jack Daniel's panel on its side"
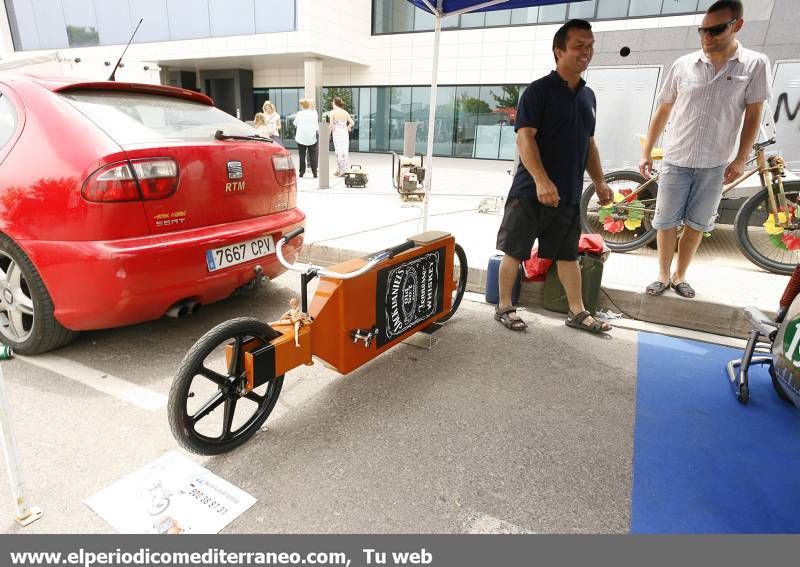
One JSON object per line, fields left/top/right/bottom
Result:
{"left": 167, "top": 227, "right": 468, "bottom": 455}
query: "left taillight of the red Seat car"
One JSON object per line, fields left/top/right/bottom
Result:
{"left": 81, "top": 158, "right": 178, "bottom": 203}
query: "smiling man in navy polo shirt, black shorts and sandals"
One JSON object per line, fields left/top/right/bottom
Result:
{"left": 494, "top": 20, "right": 613, "bottom": 333}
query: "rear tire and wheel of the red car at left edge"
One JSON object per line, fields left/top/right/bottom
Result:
{"left": 0, "top": 234, "right": 78, "bottom": 354}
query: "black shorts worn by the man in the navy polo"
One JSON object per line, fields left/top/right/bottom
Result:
{"left": 497, "top": 197, "right": 581, "bottom": 260}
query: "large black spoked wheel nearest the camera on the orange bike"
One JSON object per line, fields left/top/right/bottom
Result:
{"left": 168, "top": 317, "right": 283, "bottom": 455}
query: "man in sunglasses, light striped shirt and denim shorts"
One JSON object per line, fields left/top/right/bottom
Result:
{"left": 639, "top": 0, "right": 772, "bottom": 297}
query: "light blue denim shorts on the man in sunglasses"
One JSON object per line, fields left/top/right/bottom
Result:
{"left": 653, "top": 163, "right": 726, "bottom": 232}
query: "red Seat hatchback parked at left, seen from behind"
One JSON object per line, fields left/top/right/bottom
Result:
{"left": 0, "top": 76, "right": 305, "bottom": 354}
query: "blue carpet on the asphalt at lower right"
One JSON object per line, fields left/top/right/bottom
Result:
{"left": 631, "top": 333, "right": 800, "bottom": 533}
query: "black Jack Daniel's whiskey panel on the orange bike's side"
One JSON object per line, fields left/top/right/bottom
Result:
{"left": 375, "top": 247, "right": 446, "bottom": 348}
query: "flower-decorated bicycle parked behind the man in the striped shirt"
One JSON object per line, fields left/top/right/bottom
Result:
{"left": 580, "top": 137, "right": 800, "bottom": 274}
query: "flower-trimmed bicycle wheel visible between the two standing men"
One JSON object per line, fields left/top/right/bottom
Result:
{"left": 580, "top": 170, "right": 658, "bottom": 252}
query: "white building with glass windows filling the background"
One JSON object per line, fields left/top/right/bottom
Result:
{"left": 0, "top": 0, "right": 800, "bottom": 169}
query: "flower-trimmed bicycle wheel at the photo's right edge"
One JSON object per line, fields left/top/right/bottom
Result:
{"left": 733, "top": 183, "right": 800, "bottom": 275}
